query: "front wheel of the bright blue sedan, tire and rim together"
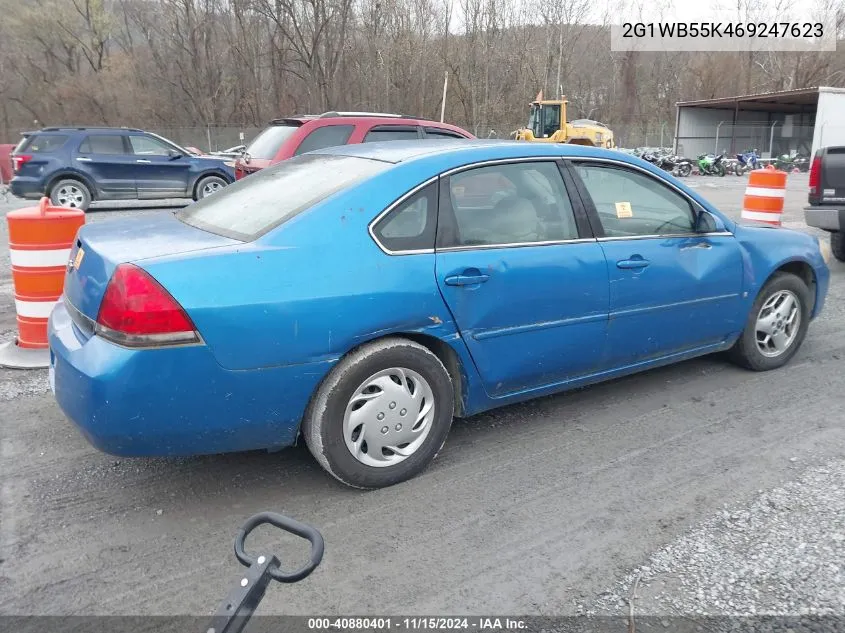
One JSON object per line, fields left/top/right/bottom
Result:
{"left": 730, "top": 273, "right": 812, "bottom": 371}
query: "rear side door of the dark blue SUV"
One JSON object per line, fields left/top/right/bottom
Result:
{"left": 73, "top": 134, "right": 137, "bottom": 200}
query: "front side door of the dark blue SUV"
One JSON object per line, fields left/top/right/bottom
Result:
{"left": 129, "top": 134, "right": 191, "bottom": 200}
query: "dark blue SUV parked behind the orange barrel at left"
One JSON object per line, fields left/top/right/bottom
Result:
{"left": 10, "top": 127, "right": 235, "bottom": 209}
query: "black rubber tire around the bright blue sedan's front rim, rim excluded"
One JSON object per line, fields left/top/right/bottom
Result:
{"left": 729, "top": 273, "right": 813, "bottom": 371}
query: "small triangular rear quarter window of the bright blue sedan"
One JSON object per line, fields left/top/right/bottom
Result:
{"left": 373, "top": 182, "right": 437, "bottom": 252}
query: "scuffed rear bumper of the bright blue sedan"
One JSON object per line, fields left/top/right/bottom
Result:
{"left": 49, "top": 301, "right": 333, "bottom": 457}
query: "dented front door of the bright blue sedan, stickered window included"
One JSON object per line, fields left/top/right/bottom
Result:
{"left": 571, "top": 161, "right": 744, "bottom": 367}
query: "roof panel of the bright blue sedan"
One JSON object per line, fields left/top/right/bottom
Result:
{"left": 314, "top": 139, "right": 627, "bottom": 163}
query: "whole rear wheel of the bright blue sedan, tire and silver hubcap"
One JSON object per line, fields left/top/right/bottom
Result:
{"left": 302, "top": 338, "right": 454, "bottom": 488}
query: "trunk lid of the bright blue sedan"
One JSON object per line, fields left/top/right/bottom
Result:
{"left": 64, "top": 212, "right": 241, "bottom": 320}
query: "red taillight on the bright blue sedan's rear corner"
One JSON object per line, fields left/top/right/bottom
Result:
{"left": 97, "top": 264, "right": 199, "bottom": 347}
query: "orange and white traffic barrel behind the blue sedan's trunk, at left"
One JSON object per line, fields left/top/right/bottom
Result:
{"left": 0, "top": 198, "right": 85, "bottom": 368}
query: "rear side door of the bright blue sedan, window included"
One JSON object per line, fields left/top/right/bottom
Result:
{"left": 435, "top": 160, "right": 609, "bottom": 397}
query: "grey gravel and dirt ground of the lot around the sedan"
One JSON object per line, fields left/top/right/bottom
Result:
{"left": 0, "top": 175, "right": 845, "bottom": 616}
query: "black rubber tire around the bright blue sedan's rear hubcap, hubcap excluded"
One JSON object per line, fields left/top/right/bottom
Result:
{"left": 302, "top": 337, "right": 454, "bottom": 489}
